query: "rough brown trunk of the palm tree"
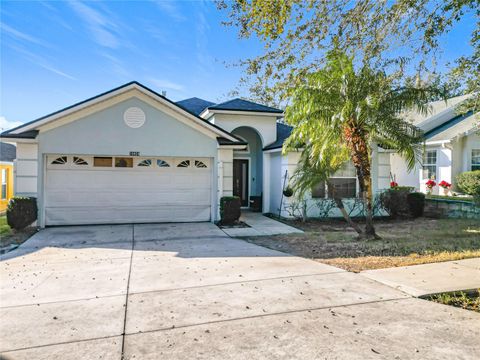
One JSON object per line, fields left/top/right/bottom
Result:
{"left": 344, "top": 123, "right": 380, "bottom": 239}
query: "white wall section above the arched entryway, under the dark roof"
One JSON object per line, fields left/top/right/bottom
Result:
{"left": 210, "top": 114, "right": 277, "bottom": 147}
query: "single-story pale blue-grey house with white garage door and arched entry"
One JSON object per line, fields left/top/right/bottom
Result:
{"left": 1, "top": 82, "right": 390, "bottom": 226}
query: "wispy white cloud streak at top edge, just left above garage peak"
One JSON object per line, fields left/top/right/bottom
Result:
{"left": 69, "top": 1, "right": 120, "bottom": 49}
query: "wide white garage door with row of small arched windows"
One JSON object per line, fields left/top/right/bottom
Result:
{"left": 45, "top": 155, "right": 212, "bottom": 225}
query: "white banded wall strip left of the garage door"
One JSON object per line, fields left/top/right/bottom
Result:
{"left": 15, "top": 143, "right": 39, "bottom": 197}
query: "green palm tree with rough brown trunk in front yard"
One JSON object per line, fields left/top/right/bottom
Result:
{"left": 284, "top": 50, "right": 431, "bottom": 238}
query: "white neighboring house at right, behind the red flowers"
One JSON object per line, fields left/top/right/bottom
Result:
{"left": 390, "top": 95, "right": 480, "bottom": 194}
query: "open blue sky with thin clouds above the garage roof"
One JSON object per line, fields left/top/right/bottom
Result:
{"left": 0, "top": 1, "right": 473, "bottom": 129}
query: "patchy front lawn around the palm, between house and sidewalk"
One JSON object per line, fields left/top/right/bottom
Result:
{"left": 246, "top": 218, "right": 480, "bottom": 272}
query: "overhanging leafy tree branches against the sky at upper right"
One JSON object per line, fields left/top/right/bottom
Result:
{"left": 217, "top": 0, "right": 480, "bottom": 110}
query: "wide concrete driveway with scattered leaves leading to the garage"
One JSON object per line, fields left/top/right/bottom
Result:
{"left": 0, "top": 223, "right": 480, "bottom": 360}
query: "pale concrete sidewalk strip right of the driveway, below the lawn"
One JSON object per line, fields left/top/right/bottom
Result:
{"left": 360, "top": 258, "right": 480, "bottom": 297}
